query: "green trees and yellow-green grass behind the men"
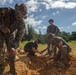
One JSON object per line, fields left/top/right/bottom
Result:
{"left": 20, "top": 25, "right": 76, "bottom": 50}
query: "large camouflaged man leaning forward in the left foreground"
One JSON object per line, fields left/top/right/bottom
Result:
{"left": 0, "top": 4, "right": 27, "bottom": 75}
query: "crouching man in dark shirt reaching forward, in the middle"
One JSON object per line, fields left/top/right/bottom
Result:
{"left": 24, "top": 39, "right": 42, "bottom": 56}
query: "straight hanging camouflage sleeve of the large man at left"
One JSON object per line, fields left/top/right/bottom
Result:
{"left": 12, "top": 23, "right": 25, "bottom": 48}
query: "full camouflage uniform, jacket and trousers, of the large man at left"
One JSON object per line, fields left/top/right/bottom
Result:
{"left": 0, "top": 3, "right": 25, "bottom": 75}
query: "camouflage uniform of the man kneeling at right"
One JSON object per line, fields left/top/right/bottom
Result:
{"left": 53, "top": 37, "right": 71, "bottom": 59}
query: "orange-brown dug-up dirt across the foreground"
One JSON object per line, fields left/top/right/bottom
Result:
{"left": 16, "top": 56, "right": 76, "bottom": 75}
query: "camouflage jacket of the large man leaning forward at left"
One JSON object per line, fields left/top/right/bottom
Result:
{"left": 0, "top": 8, "right": 25, "bottom": 48}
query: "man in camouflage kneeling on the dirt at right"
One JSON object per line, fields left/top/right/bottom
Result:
{"left": 48, "top": 33, "right": 71, "bottom": 60}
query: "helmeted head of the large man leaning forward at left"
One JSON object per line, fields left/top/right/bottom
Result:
{"left": 15, "top": 4, "right": 27, "bottom": 18}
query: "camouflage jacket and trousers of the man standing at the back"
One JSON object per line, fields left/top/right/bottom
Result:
{"left": 47, "top": 21, "right": 60, "bottom": 55}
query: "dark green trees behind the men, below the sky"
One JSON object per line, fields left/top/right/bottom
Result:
{"left": 22, "top": 25, "right": 76, "bottom": 43}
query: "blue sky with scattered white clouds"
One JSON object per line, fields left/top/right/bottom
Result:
{"left": 0, "top": 0, "right": 76, "bottom": 34}
